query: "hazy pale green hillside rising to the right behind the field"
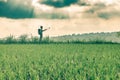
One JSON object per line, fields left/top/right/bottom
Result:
{"left": 52, "top": 32, "right": 120, "bottom": 43}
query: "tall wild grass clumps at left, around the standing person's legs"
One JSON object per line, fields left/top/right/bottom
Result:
{"left": 0, "top": 34, "right": 53, "bottom": 44}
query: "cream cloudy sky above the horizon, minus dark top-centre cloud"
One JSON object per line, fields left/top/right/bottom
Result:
{"left": 0, "top": 0, "right": 120, "bottom": 38}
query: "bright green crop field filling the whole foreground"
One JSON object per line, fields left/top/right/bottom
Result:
{"left": 0, "top": 44, "right": 120, "bottom": 80}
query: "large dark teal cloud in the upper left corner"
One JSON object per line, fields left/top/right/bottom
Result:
{"left": 0, "top": 0, "right": 33, "bottom": 18}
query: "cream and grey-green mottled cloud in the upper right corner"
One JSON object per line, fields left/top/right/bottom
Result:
{"left": 83, "top": 3, "right": 120, "bottom": 20}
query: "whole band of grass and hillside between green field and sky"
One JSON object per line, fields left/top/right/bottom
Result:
{"left": 0, "top": 32, "right": 120, "bottom": 44}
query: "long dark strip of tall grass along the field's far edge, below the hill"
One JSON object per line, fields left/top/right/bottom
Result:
{"left": 0, "top": 35, "right": 117, "bottom": 44}
